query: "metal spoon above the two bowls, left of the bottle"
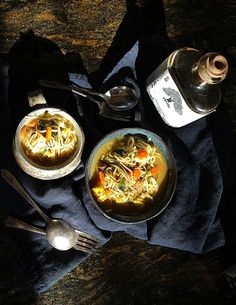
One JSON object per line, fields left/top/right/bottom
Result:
{"left": 39, "top": 78, "right": 140, "bottom": 111}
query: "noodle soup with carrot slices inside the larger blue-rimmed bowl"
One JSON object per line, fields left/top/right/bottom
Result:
{"left": 89, "top": 134, "right": 171, "bottom": 215}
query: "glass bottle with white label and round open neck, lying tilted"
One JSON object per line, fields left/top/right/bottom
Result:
{"left": 146, "top": 47, "right": 228, "bottom": 127}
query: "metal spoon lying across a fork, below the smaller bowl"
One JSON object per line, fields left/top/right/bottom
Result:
{"left": 1, "top": 169, "right": 99, "bottom": 250}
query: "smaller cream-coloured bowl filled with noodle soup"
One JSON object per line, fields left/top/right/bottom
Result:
{"left": 13, "top": 107, "right": 84, "bottom": 180}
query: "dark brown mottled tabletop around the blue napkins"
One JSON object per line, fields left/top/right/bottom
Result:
{"left": 0, "top": 0, "right": 236, "bottom": 305}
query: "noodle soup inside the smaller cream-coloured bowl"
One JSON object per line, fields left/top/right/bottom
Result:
{"left": 19, "top": 111, "right": 78, "bottom": 166}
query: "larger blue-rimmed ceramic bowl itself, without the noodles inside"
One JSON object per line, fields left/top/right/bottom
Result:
{"left": 85, "top": 128, "right": 176, "bottom": 224}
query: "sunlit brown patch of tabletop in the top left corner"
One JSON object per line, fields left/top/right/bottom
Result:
{"left": 0, "top": 0, "right": 125, "bottom": 69}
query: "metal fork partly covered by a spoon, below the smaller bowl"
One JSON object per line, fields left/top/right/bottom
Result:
{"left": 5, "top": 216, "right": 98, "bottom": 253}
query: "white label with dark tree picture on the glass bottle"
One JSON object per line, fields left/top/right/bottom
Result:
{"left": 147, "top": 70, "right": 206, "bottom": 127}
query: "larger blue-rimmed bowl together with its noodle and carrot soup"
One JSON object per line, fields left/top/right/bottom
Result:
{"left": 85, "top": 128, "right": 176, "bottom": 224}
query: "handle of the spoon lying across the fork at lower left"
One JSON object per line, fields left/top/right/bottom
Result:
{"left": 1, "top": 169, "right": 50, "bottom": 222}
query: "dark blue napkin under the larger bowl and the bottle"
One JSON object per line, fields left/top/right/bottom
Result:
{"left": 70, "top": 35, "right": 233, "bottom": 253}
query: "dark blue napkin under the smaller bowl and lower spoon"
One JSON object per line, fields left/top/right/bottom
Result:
{"left": 0, "top": 54, "right": 111, "bottom": 292}
